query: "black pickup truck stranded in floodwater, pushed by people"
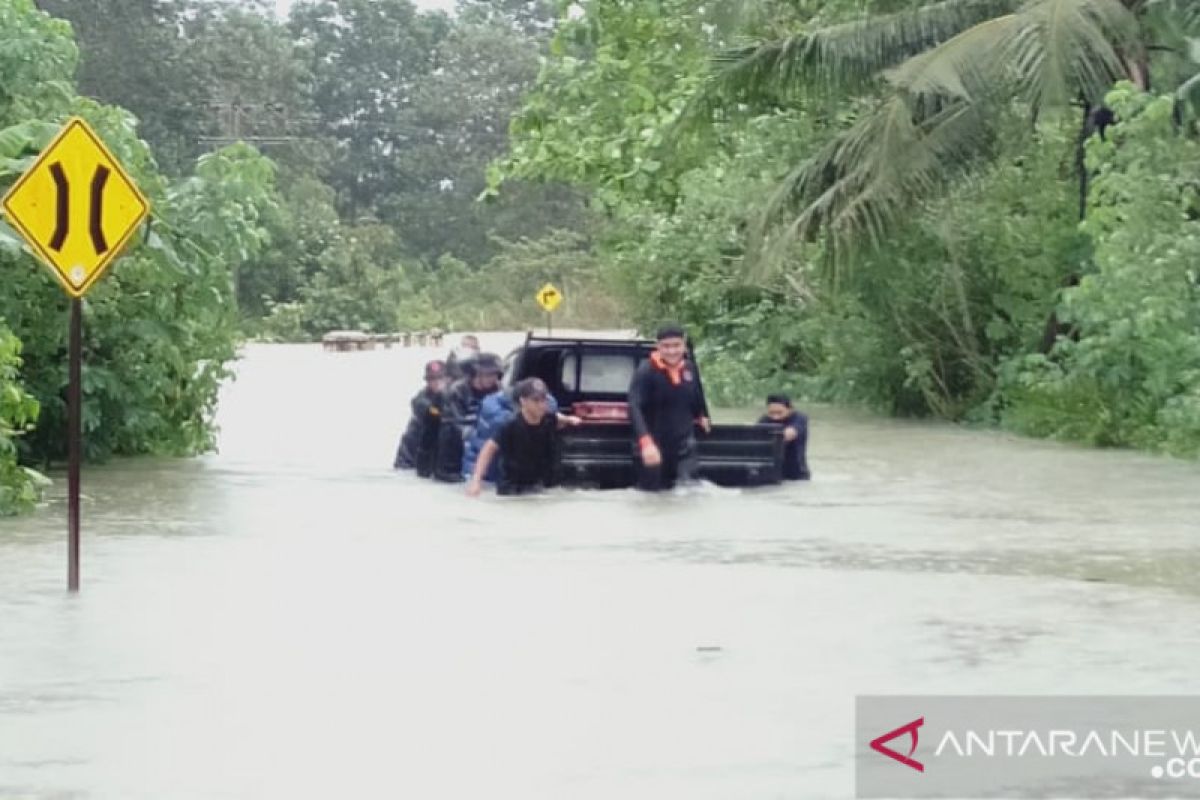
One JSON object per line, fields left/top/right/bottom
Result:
{"left": 504, "top": 333, "right": 784, "bottom": 488}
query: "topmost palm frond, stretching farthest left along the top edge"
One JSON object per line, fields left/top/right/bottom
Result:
{"left": 697, "top": 0, "right": 1019, "bottom": 110}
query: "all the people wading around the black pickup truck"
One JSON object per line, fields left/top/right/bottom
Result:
{"left": 394, "top": 325, "right": 810, "bottom": 497}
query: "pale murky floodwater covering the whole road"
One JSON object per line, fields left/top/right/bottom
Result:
{"left": 0, "top": 337, "right": 1200, "bottom": 800}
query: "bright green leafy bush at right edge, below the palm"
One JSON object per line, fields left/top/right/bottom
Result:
{"left": 1006, "top": 84, "right": 1200, "bottom": 456}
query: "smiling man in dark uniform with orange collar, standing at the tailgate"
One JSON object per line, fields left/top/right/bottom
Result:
{"left": 629, "top": 325, "right": 710, "bottom": 492}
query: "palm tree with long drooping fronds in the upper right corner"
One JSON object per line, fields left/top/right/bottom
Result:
{"left": 694, "top": 0, "right": 1200, "bottom": 256}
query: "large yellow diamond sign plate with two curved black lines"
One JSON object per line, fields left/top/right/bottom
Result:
{"left": 4, "top": 118, "right": 150, "bottom": 297}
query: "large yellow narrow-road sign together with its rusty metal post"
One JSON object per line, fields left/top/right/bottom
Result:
{"left": 0, "top": 118, "right": 150, "bottom": 591}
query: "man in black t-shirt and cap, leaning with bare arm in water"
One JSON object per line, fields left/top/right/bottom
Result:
{"left": 467, "top": 378, "right": 580, "bottom": 497}
